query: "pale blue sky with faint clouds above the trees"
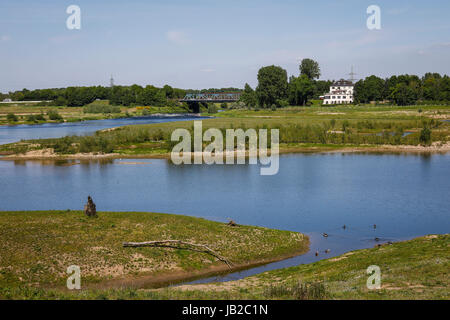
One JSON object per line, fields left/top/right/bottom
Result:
{"left": 0, "top": 0, "right": 450, "bottom": 92}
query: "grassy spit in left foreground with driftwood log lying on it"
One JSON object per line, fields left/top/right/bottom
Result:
{"left": 0, "top": 211, "right": 309, "bottom": 299}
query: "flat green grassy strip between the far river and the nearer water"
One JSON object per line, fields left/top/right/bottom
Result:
{"left": 0, "top": 106, "right": 450, "bottom": 157}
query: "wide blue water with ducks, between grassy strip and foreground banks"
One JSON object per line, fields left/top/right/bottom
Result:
{"left": 0, "top": 153, "right": 450, "bottom": 282}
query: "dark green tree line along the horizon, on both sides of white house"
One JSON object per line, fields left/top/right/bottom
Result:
{"left": 4, "top": 59, "right": 450, "bottom": 109}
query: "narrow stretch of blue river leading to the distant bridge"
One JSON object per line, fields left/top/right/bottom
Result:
{"left": 0, "top": 115, "right": 204, "bottom": 144}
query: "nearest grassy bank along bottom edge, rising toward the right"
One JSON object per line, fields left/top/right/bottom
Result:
{"left": 3, "top": 234, "right": 450, "bottom": 300}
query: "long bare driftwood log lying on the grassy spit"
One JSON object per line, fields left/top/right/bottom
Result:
{"left": 123, "top": 240, "right": 232, "bottom": 269}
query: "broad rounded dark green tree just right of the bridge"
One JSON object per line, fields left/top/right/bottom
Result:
{"left": 256, "top": 65, "right": 288, "bottom": 108}
